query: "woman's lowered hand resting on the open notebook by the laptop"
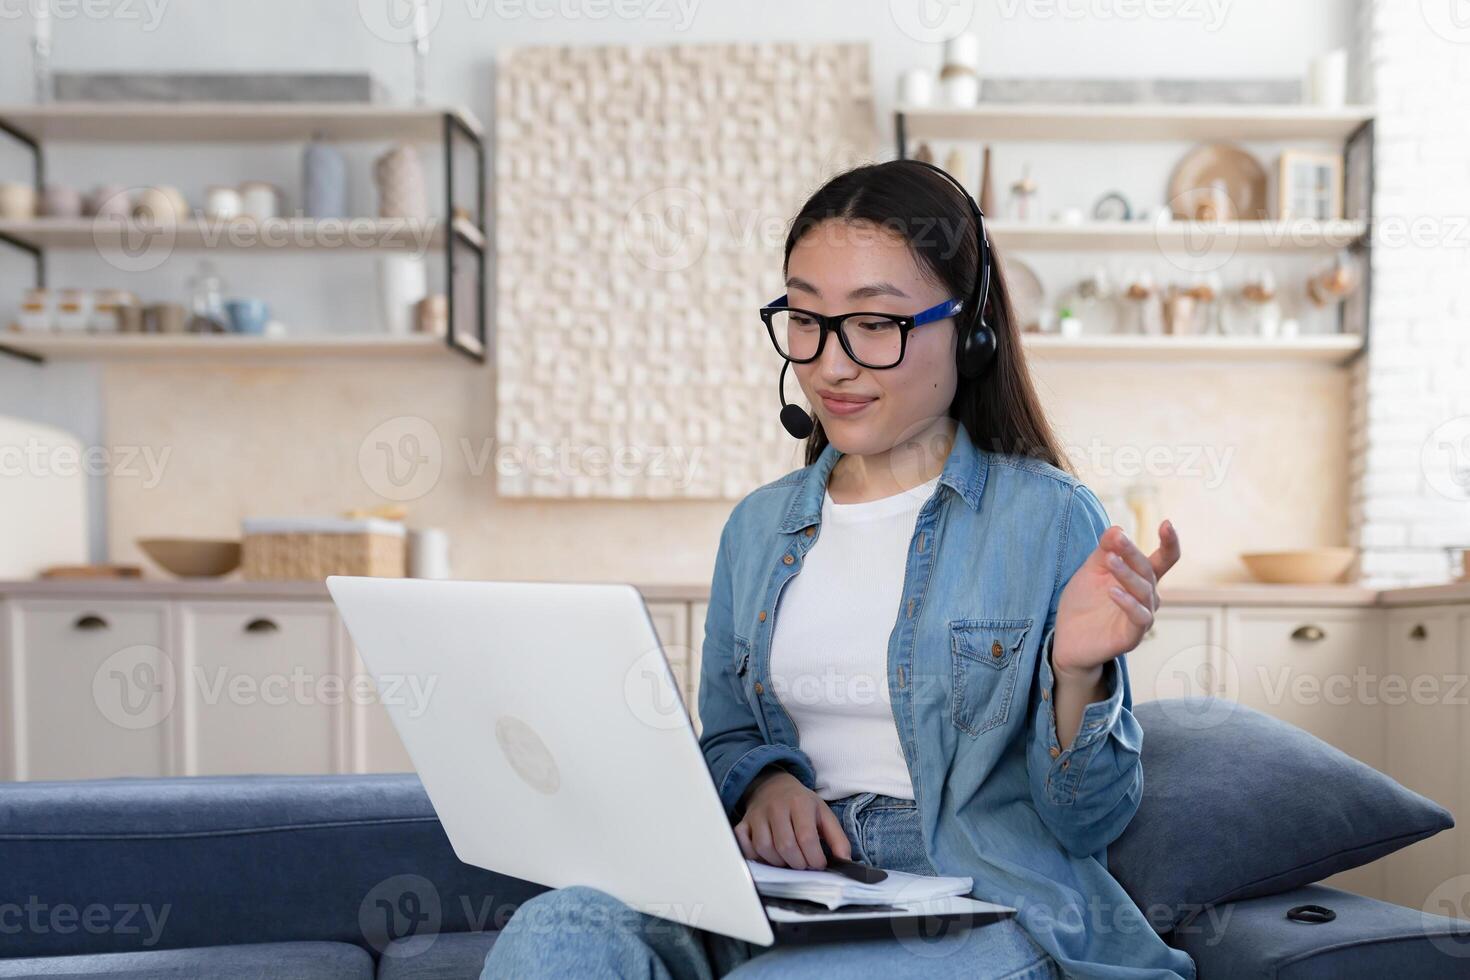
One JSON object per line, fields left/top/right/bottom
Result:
{"left": 735, "top": 768, "right": 853, "bottom": 870}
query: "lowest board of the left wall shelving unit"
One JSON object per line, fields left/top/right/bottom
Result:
{"left": 0, "top": 332, "right": 470, "bottom": 363}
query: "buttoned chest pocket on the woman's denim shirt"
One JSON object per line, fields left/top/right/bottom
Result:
{"left": 950, "top": 619, "right": 1030, "bottom": 736}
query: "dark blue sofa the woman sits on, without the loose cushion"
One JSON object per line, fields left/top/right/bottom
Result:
{"left": 0, "top": 776, "right": 1470, "bottom": 980}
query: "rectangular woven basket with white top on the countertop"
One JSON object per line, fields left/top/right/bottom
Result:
{"left": 240, "top": 520, "right": 407, "bottom": 582}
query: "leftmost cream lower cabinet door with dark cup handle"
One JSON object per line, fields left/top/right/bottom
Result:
{"left": 0, "top": 598, "right": 178, "bottom": 779}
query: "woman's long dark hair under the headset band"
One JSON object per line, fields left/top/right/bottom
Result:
{"left": 781, "top": 160, "right": 1072, "bottom": 473}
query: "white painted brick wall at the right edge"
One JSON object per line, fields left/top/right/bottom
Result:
{"left": 1348, "top": 0, "right": 1470, "bottom": 586}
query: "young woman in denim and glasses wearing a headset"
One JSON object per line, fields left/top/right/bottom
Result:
{"left": 484, "top": 160, "right": 1195, "bottom": 980}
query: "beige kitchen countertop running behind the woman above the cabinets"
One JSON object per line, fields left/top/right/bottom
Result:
{"left": 0, "top": 579, "right": 1470, "bottom": 605}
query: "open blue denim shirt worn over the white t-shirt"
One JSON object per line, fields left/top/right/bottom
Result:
{"left": 698, "top": 423, "right": 1195, "bottom": 979}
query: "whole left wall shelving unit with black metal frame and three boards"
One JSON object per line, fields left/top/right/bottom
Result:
{"left": 0, "top": 103, "right": 490, "bottom": 363}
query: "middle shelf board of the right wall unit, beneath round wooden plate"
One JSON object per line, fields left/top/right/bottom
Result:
{"left": 985, "top": 220, "right": 1367, "bottom": 253}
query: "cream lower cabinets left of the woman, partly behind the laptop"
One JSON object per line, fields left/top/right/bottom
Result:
{"left": 0, "top": 583, "right": 704, "bottom": 779}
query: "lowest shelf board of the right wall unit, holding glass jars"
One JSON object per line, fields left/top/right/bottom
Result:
{"left": 1022, "top": 334, "right": 1363, "bottom": 364}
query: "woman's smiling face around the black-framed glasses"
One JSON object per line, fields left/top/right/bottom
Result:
{"left": 786, "top": 219, "right": 958, "bottom": 455}
